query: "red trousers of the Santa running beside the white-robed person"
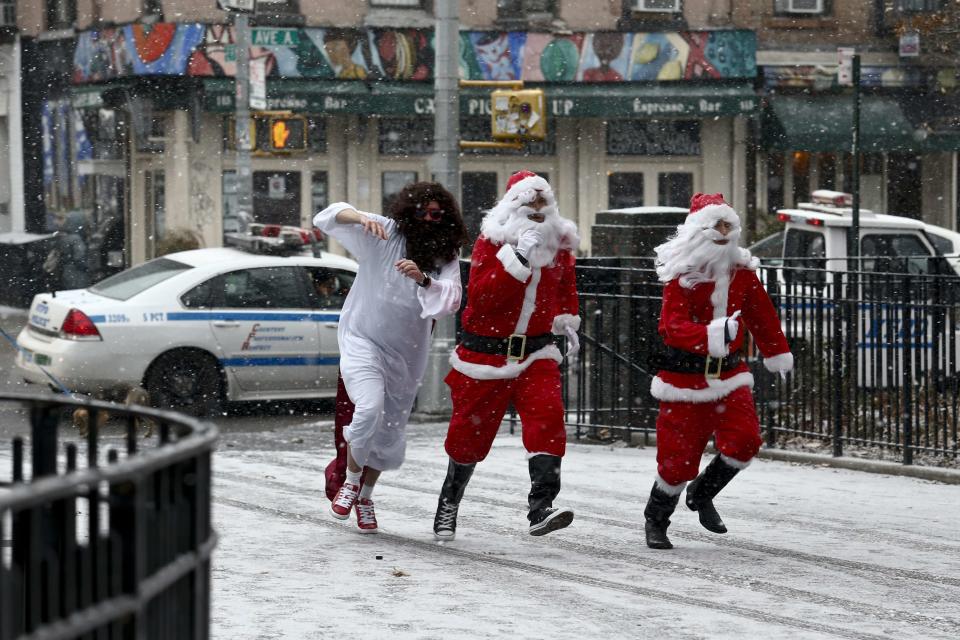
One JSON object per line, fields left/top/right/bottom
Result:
{"left": 444, "top": 360, "right": 567, "bottom": 464}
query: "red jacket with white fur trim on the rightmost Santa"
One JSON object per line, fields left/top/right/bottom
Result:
{"left": 650, "top": 268, "right": 793, "bottom": 402}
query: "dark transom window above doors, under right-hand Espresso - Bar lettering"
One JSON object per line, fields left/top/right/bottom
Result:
{"left": 607, "top": 120, "right": 701, "bottom": 156}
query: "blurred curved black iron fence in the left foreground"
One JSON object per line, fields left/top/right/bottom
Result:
{"left": 0, "top": 394, "right": 217, "bottom": 640}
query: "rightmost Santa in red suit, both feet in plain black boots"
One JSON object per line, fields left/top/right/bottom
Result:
{"left": 644, "top": 193, "right": 793, "bottom": 549}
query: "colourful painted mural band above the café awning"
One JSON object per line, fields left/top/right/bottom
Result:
{"left": 74, "top": 23, "right": 756, "bottom": 83}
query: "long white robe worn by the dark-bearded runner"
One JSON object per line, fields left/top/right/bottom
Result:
{"left": 313, "top": 202, "right": 461, "bottom": 471}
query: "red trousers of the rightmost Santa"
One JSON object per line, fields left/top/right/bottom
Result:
{"left": 657, "top": 387, "right": 763, "bottom": 485}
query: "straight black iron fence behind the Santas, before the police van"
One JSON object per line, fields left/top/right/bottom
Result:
{"left": 564, "top": 258, "right": 960, "bottom": 464}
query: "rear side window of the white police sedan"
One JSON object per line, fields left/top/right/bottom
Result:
{"left": 220, "top": 267, "right": 308, "bottom": 309}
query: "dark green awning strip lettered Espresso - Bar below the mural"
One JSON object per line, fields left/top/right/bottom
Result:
{"left": 203, "top": 78, "right": 757, "bottom": 118}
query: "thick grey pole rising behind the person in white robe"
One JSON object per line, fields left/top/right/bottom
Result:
{"left": 417, "top": 0, "right": 460, "bottom": 417}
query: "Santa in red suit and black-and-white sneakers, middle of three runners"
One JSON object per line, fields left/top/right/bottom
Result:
{"left": 433, "top": 171, "right": 580, "bottom": 540}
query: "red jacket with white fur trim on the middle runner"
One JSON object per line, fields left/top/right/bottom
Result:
{"left": 450, "top": 235, "right": 580, "bottom": 380}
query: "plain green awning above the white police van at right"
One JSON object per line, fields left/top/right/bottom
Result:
{"left": 763, "top": 95, "right": 960, "bottom": 153}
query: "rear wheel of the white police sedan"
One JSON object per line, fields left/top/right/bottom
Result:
{"left": 146, "top": 351, "right": 222, "bottom": 416}
